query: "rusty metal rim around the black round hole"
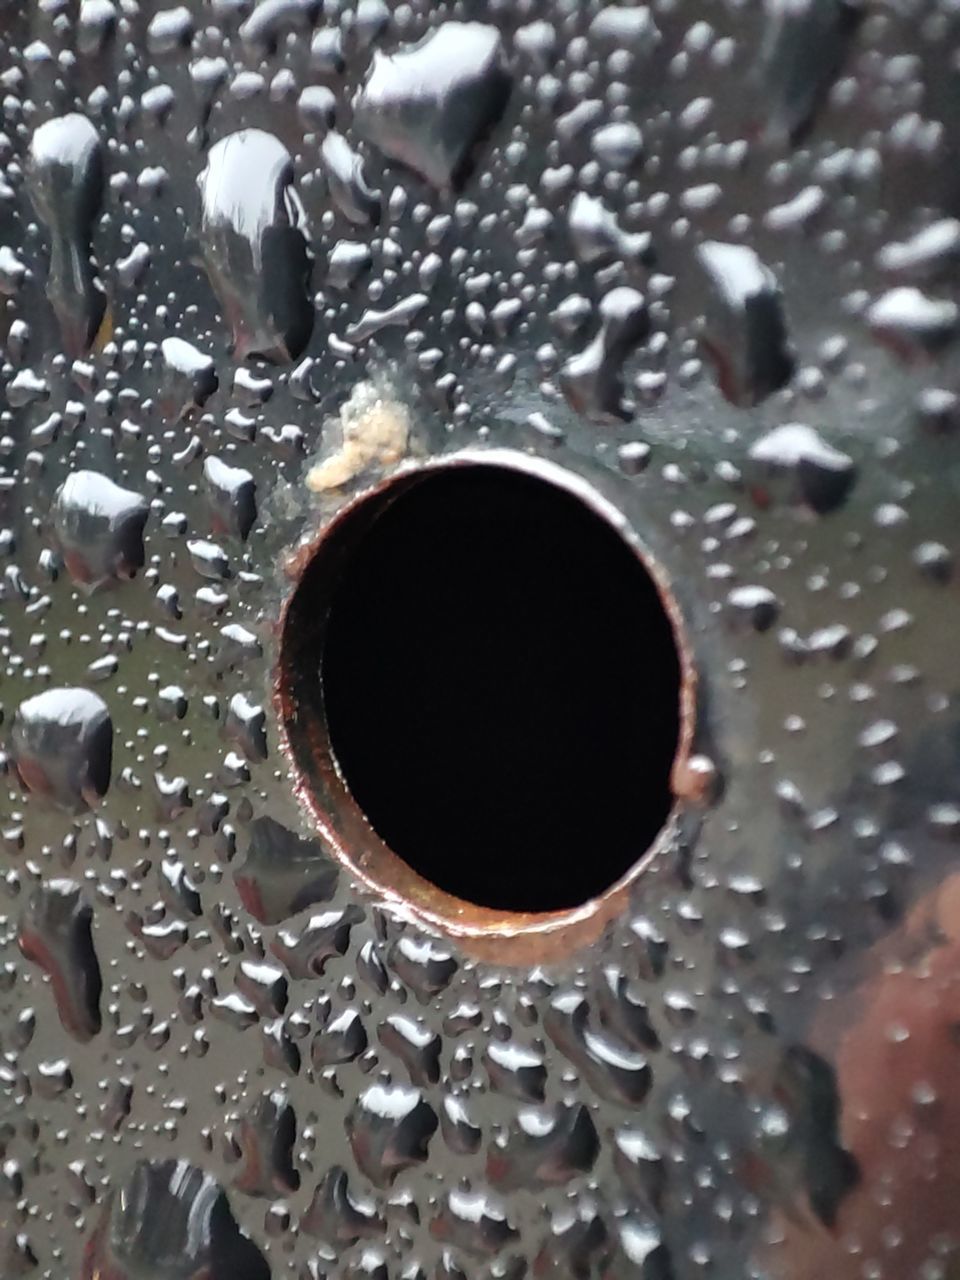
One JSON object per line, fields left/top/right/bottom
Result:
{"left": 274, "top": 448, "right": 698, "bottom": 964}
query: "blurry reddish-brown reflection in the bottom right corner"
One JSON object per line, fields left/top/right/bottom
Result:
{"left": 764, "top": 874, "right": 960, "bottom": 1280}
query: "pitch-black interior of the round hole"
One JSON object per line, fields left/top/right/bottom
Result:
{"left": 316, "top": 466, "right": 680, "bottom": 911}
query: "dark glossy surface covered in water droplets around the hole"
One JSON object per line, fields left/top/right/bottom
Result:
{"left": 0, "top": 0, "right": 960, "bottom": 1280}
